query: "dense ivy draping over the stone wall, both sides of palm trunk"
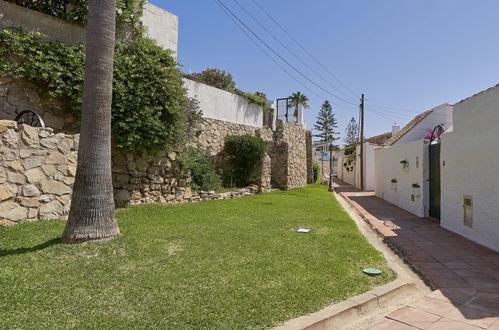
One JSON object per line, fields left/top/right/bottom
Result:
{"left": 0, "top": 29, "right": 189, "bottom": 151}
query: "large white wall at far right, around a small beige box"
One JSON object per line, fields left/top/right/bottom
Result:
{"left": 441, "top": 87, "right": 499, "bottom": 251}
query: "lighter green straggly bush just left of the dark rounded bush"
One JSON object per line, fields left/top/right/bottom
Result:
{"left": 176, "top": 147, "right": 221, "bottom": 191}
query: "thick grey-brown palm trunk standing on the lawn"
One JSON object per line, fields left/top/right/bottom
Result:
{"left": 62, "top": 0, "right": 120, "bottom": 243}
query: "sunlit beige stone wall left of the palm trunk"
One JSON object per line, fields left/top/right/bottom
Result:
{"left": 0, "top": 120, "right": 79, "bottom": 225}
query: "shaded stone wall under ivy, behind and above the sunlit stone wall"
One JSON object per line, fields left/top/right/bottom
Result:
{"left": 0, "top": 77, "right": 79, "bottom": 134}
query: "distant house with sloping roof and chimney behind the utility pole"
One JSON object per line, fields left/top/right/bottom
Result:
{"left": 335, "top": 130, "right": 399, "bottom": 191}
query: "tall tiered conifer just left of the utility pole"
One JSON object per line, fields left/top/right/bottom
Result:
{"left": 314, "top": 100, "right": 339, "bottom": 191}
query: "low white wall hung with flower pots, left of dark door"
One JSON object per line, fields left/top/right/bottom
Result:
{"left": 374, "top": 140, "right": 428, "bottom": 217}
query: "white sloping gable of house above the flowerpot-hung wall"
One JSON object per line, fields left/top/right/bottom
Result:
{"left": 393, "top": 104, "right": 453, "bottom": 145}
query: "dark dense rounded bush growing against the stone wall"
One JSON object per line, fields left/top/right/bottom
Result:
{"left": 224, "top": 134, "right": 267, "bottom": 187}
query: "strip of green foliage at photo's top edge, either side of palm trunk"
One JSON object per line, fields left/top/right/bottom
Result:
{"left": 5, "top": 0, "right": 145, "bottom": 26}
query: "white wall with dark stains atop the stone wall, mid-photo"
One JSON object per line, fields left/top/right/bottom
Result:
{"left": 184, "top": 79, "right": 263, "bottom": 127}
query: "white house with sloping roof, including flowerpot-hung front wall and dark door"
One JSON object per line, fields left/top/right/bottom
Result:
{"left": 374, "top": 104, "right": 453, "bottom": 218}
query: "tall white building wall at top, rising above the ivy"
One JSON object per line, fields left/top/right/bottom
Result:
{"left": 142, "top": 2, "right": 178, "bottom": 54}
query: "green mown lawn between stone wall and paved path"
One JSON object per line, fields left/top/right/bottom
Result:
{"left": 0, "top": 185, "right": 394, "bottom": 329}
